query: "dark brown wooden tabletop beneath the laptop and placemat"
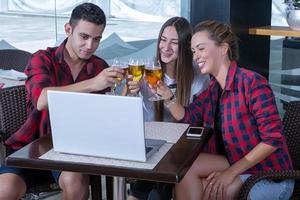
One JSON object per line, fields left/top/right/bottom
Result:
{"left": 6, "top": 128, "right": 212, "bottom": 199}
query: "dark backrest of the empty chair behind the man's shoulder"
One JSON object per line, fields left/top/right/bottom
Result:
{"left": 0, "top": 49, "right": 32, "bottom": 72}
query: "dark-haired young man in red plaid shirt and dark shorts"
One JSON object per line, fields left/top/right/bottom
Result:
{"left": 0, "top": 3, "right": 139, "bottom": 200}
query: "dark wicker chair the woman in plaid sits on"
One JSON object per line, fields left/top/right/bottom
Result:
{"left": 239, "top": 101, "right": 300, "bottom": 200}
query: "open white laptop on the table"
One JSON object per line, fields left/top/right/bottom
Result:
{"left": 47, "top": 91, "right": 166, "bottom": 162}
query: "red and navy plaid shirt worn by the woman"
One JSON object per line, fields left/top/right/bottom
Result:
{"left": 181, "top": 62, "right": 293, "bottom": 174}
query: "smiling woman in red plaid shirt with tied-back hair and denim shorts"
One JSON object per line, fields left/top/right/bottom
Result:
{"left": 157, "top": 21, "right": 294, "bottom": 200}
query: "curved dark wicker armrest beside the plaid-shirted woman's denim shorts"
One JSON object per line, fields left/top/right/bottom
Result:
{"left": 239, "top": 170, "right": 300, "bottom": 200}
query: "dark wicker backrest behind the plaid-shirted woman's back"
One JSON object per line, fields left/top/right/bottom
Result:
{"left": 283, "top": 101, "right": 300, "bottom": 170}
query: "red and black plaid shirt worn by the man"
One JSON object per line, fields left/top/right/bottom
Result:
{"left": 5, "top": 40, "right": 108, "bottom": 150}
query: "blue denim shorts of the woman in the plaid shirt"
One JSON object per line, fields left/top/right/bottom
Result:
{"left": 240, "top": 174, "right": 295, "bottom": 200}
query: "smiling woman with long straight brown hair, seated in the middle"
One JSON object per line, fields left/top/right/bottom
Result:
{"left": 129, "top": 17, "right": 209, "bottom": 200}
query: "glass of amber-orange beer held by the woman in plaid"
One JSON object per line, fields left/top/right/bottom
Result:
{"left": 145, "top": 58, "right": 162, "bottom": 101}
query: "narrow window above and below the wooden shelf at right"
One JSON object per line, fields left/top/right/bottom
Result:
{"left": 269, "top": 0, "right": 300, "bottom": 115}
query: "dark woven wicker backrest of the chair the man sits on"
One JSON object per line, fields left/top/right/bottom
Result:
{"left": 0, "top": 85, "right": 27, "bottom": 140}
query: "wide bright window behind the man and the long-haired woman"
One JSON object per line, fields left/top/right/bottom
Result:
{"left": 0, "top": 0, "right": 189, "bottom": 52}
